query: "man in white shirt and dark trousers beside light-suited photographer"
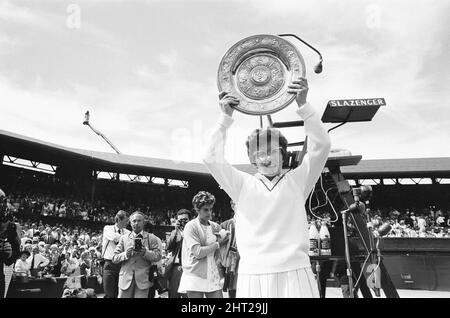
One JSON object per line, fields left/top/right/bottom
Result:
{"left": 102, "top": 210, "right": 130, "bottom": 298}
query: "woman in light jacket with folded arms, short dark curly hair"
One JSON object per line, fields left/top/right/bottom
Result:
{"left": 178, "top": 191, "right": 228, "bottom": 298}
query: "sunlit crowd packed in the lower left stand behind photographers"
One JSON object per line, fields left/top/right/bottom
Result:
{"left": 8, "top": 219, "right": 174, "bottom": 296}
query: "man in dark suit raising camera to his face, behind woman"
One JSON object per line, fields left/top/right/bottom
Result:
{"left": 165, "top": 209, "right": 191, "bottom": 298}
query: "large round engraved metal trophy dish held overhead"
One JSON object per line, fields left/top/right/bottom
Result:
{"left": 217, "top": 34, "right": 306, "bottom": 116}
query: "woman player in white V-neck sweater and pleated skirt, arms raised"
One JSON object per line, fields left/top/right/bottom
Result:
{"left": 203, "top": 78, "right": 331, "bottom": 298}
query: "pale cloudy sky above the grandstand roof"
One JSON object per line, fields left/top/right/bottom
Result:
{"left": 0, "top": 0, "right": 450, "bottom": 164}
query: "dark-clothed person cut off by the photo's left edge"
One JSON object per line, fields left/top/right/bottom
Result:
{"left": 0, "top": 189, "right": 20, "bottom": 298}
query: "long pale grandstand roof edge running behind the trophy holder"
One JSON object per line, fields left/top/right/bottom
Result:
{"left": 0, "top": 130, "right": 450, "bottom": 180}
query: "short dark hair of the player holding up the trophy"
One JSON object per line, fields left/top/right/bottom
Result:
{"left": 245, "top": 127, "right": 288, "bottom": 163}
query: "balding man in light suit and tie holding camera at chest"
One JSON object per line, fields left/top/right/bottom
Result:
{"left": 112, "top": 211, "right": 161, "bottom": 298}
